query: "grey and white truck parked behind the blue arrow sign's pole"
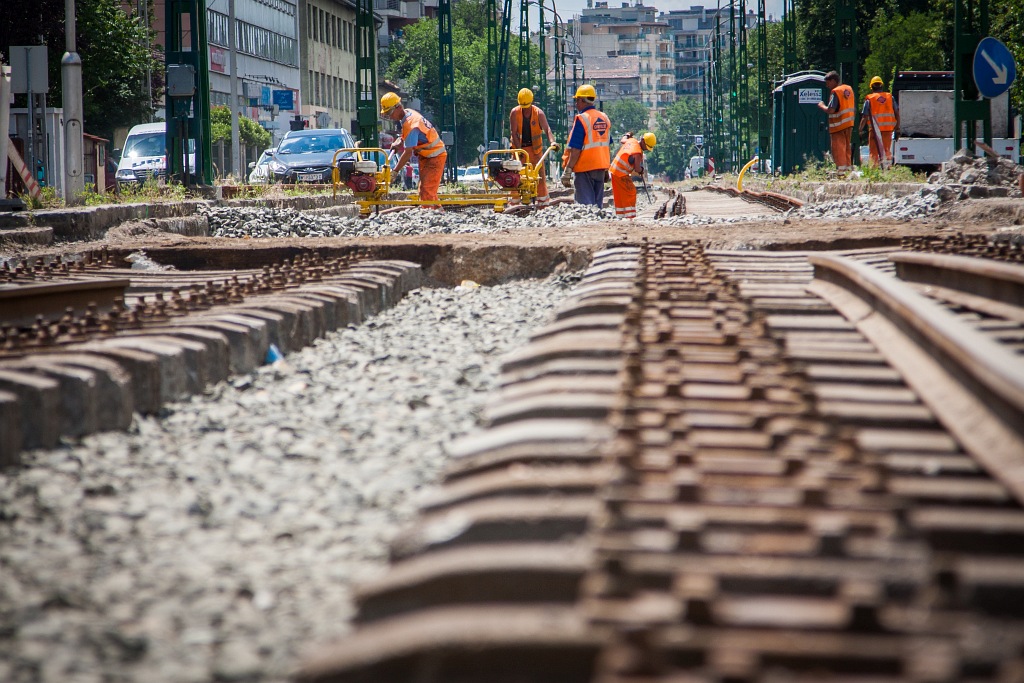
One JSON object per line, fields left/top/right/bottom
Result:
{"left": 892, "top": 71, "right": 1020, "bottom": 170}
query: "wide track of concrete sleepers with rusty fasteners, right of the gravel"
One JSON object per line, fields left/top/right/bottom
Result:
{"left": 299, "top": 243, "right": 1024, "bottom": 683}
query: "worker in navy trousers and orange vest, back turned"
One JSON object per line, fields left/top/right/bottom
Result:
{"left": 562, "top": 84, "right": 611, "bottom": 207}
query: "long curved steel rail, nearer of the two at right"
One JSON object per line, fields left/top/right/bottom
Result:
{"left": 808, "top": 255, "right": 1024, "bottom": 503}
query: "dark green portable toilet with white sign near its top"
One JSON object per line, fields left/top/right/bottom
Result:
{"left": 772, "top": 72, "right": 829, "bottom": 174}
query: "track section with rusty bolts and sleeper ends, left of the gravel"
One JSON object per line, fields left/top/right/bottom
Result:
{"left": 0, "top": 253, "right": 422, "bottom": 465}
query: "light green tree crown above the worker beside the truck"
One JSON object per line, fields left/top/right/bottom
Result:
{"left": 859, "top": 9, "right": 946, "bottom": 97}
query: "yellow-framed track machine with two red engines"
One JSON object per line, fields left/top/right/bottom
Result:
{"left": 331, "top": 144, "right": 558, "bottom": 216}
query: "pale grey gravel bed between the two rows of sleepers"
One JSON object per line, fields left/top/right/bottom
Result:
{"left": 0, "top": 280, "right": 566, "bottom": 683}
